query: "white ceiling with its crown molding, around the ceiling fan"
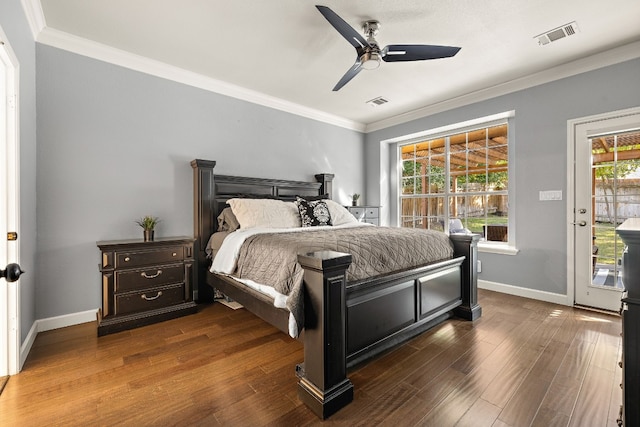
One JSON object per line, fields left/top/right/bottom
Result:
{"left": 32, "top": 0, "right": 640, "bottom": 129}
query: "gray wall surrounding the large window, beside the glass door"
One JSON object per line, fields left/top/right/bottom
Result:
{"left": 365, "top": 59, "right": 640, "bottom": 294}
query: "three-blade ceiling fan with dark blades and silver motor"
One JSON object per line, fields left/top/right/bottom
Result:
{"left": 316, "top": 5, "right": 460, "bottom": 91}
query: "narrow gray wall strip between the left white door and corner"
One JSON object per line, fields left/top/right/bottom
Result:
{"left": 0, "top": 0, "right": 37, "bottom": 342}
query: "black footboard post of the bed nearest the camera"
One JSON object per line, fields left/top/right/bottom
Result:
{"left": 296, "top": 251, "right": 353, "bottom": 419}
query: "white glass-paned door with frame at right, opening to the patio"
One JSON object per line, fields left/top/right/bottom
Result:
{"left": 569, "top": 109, "right": 640, "bottom": 311}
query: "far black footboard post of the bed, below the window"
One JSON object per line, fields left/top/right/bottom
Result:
{"left": 449, "top": 234, "right": 482, "bottom": 320}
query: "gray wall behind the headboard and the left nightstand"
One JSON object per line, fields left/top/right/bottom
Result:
{"left": 36, "top": 45, "right": 364, "bottom": 318}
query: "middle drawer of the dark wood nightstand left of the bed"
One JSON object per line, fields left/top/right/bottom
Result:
{"left": 114, "top": 264, "right": 184, "bottom": 293}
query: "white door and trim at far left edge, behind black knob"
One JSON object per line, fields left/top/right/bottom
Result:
{"left": 0, "top": 28, "right": 20, "bottom": 376}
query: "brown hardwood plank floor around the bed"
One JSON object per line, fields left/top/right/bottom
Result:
{"left": 0, "top": 291, "right": 622, "bottom": 427}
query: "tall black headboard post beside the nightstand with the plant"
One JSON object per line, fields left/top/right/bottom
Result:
{"left": 191, "top": 159, "right": 216, "bottom": 301}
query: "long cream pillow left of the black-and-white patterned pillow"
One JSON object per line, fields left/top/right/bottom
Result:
{"left": 227, "top": 199, "right": 301, "bottom": 228}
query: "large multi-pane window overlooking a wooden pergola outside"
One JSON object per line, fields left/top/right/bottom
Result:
{"left": 398, "top": 119, "right": 509, "bottom": 244}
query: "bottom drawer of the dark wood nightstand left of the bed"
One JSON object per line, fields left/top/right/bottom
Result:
{"left": 115, "top": 283, "right": 185, "bottom": 315}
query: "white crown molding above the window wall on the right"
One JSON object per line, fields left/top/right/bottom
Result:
{"left": 365, "top": 41, "right": 640, "bottom": 133}
